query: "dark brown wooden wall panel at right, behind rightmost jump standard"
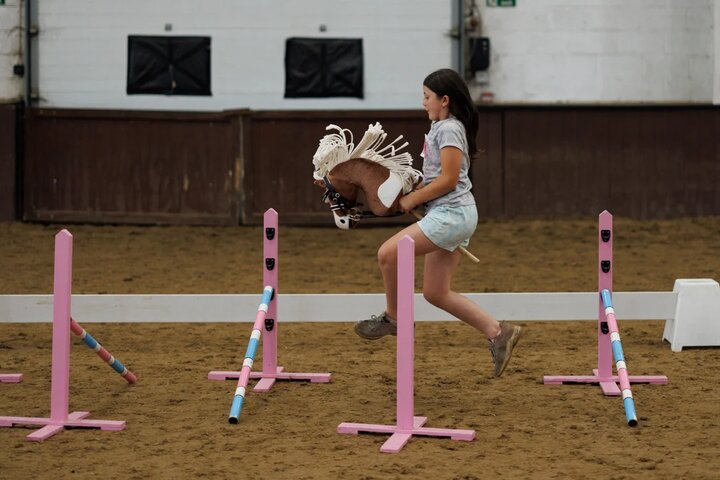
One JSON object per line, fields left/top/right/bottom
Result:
{"left": 496, "top": 107, "right": 720, "bottom": 218}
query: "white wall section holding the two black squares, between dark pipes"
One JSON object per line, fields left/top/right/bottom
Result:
{"left": 38, "top": 0, "right": 452, "bottom": 110}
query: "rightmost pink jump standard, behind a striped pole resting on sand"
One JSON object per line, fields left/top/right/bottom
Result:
{"left": 543, "top": 210, "right": 667, "bottom": 426}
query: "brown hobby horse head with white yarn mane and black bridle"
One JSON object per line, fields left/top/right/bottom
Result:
{"left": 313, "top": 123, "right": 422, "bottom": 230}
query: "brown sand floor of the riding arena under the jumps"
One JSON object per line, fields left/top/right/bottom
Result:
{"left": 0, "top": 216, "right": 720, "bottom": 479}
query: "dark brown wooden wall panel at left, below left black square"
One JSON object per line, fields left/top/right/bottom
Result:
{"left": 24, "top": 109, "right": 248, "bottom": 225}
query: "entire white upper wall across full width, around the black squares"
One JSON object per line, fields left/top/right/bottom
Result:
{"left": 0, "top": 0, "right": 720, "bottom": 111}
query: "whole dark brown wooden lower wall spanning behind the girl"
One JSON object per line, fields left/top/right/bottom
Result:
{"left": 12, "top": 106, "right": 720, "bottom": 225}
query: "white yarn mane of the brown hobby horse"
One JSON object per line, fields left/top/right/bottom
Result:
{"left": 313, "top": 122, "right": 422, "bottom": 194}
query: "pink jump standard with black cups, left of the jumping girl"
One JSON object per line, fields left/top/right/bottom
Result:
{"left": 208, "top": 208, "right": 330, "bottom": 423}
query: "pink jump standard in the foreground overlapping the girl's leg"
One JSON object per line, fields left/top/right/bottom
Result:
{"left": 337, "top": 235, "right": 475, "bottom": 453}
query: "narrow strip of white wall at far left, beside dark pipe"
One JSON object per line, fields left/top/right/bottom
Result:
{"left": 0, "top": 0, "right": 23, "bottom": 103}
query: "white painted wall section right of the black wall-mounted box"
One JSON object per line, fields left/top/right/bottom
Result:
{"left": 478, "top": 0, "right": 720, "bottom": 103}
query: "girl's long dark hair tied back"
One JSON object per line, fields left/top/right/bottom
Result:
{"left": 423, "top": 68, "right": 478, "bottom": 159}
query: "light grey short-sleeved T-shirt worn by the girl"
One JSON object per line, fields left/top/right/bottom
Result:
{"left": 421, "top": 115, "right": 475, "bottom": 207}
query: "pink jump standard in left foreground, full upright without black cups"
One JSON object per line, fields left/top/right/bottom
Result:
{"left": 0, "top": 230, "right": 131, "bottom": 442}
